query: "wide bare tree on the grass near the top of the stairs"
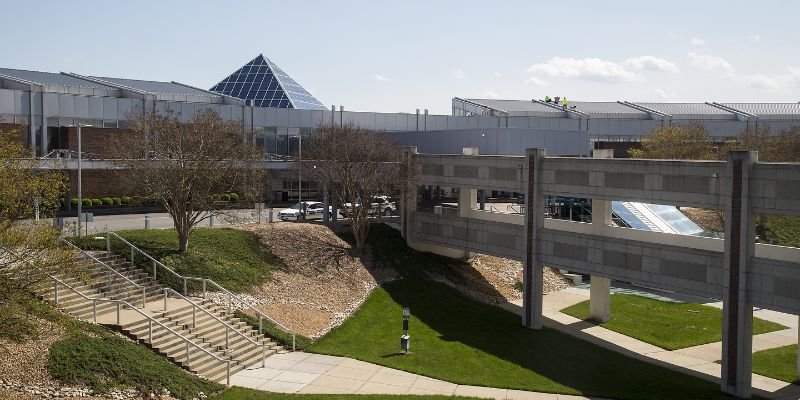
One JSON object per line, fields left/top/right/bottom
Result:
{"left": 115, "top": 110, "right": 266, "bottom": 253}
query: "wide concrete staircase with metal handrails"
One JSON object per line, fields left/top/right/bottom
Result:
{"left": 38, "top": 252, "right": 282, "bottom": 382}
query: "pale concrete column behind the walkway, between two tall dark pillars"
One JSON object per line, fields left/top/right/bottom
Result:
{"left": 589, "top": 150, "right": 614, "bottom": 322}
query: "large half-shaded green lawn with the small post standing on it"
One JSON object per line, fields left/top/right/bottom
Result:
{"left": 310, "top": 278, "right": 744, "bottom": 399}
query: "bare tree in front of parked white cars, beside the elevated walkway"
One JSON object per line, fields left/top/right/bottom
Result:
{"left": 299, "top": 124, "right": 416, "bottom": 251}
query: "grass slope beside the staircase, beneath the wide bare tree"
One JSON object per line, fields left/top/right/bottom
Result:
{"left": 73, "top": 228, "right": 283, "bottom": 293}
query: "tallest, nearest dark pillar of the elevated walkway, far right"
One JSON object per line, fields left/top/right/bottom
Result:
{"left": 721, "top": 151, "right": 758, "bottom": 398}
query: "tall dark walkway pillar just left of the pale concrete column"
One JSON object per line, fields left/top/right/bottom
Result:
{"left": 522, "top": 149, "right": 545, "bottom": 329}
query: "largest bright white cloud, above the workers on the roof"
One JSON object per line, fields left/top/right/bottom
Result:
{"left": 528, "top": 57, "right": 639, "bottom": 82}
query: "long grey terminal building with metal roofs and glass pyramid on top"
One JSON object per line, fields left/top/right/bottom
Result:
{"left": 0, "top": 55, "right": 800, "bottom": 200}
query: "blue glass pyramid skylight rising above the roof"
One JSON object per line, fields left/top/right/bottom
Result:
{"left": 211, "top": 54, "right": 326, "bottom": 110}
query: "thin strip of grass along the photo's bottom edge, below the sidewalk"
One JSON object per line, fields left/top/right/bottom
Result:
{"left": 211, "top": 387, "right": 477, "bottom": 400}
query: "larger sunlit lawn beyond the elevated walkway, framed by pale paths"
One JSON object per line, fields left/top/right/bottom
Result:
{"left": 561, "top": 294, "right": 786, "bottom": 350}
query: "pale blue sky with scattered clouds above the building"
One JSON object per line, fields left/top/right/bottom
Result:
{"left": 0, "top": 0, "right": 800, "bottom": 114}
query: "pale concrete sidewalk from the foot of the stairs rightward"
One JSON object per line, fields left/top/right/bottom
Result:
{"left": 231, "top": 352, "right": 604, "bottom": 400}
